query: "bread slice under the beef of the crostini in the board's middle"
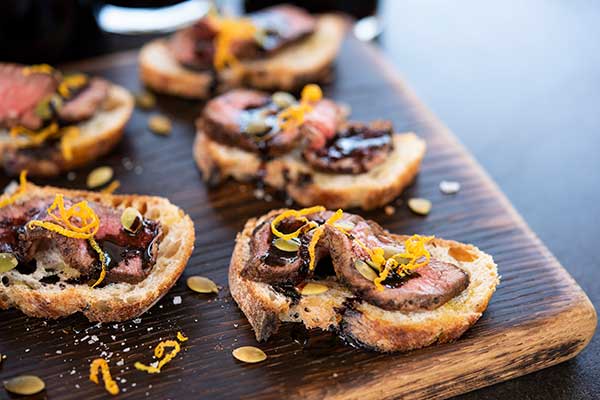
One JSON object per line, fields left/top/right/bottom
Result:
{"left": 194, "top": 131, "right": 426, "bottom": 210}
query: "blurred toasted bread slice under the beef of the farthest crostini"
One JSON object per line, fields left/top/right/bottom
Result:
{"left": 139, "top": 14, "right": 347, "bottom": 99}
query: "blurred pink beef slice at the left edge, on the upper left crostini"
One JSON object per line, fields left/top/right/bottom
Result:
{"left": 0, "top": 63, "right": 58, "bottom": 130}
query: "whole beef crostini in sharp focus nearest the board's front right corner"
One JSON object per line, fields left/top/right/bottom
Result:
{"left": 229, "top": 206, "right": 499, "bottom": 352}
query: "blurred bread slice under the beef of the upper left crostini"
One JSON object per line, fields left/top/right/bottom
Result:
{"left": 0, "top": 85, "right": 134, "bottom": 176}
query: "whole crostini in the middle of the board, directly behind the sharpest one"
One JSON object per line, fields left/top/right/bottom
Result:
{"left": 194, "top": 84, "right": 426, "bottom": 209}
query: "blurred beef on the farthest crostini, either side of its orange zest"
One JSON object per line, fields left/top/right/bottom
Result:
{"left": 168, "top": 5, "right": 316, "bottom": 70}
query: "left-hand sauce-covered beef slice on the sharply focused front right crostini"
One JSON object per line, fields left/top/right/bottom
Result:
{"left": 242, "top": 211, "right": 333, "bottom": 284}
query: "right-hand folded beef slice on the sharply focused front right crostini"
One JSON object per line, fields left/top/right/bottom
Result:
{"left": 326, "top": 221, "right": 469, "bottom": 312}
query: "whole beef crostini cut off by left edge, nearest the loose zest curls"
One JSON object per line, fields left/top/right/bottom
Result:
{"left": 0, "top": 174, "right": 194, "bottom": 322}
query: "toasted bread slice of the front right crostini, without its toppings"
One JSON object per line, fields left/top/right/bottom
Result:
{"left": 229, "top": 210, "right": 499, "bottom": 352}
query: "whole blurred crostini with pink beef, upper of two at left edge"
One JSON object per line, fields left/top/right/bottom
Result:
{"left": 0, "top": 63, "right": 134, "bottom": 176}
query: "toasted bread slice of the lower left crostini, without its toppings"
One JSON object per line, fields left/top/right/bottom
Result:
{"left": 0, "top": 184, "right": 194, "bottom": 322}
